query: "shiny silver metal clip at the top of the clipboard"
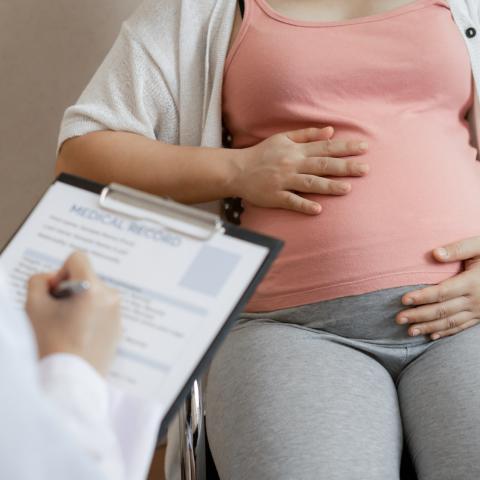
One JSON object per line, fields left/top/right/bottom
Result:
{"left": 99, "top": 183, "right": 225, "bottom": 241}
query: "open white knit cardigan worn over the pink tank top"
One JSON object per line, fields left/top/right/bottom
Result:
{"left": 58, "top": 0, "right": 480, "bottom": 152}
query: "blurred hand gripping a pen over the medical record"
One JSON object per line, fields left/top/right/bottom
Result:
{"left": 26, "top": 252, "right": 120, "bottom": 375}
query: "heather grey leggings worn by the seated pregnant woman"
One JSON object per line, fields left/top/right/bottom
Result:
{"left": 206, "top": 285, "right": 480, "bottom": 480}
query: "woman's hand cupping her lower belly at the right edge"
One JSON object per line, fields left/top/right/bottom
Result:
{"left": 396, "top": 236, "right": 480, "bottom": 340}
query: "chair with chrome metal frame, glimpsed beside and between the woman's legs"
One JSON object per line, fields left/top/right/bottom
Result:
{"left": 178, "top": 380, "right": 417, "bottom": 480}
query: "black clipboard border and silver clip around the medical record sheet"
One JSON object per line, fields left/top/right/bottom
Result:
{"left": 0, "top": 174, "right": 283, "bottom": 432}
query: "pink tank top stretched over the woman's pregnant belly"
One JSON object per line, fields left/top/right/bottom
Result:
{"left": 223, "top": 0, "right": 480, "bottom": 311}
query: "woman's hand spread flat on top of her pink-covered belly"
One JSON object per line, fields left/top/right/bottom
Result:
{"left": 232, "top": 127, "right": 369, "bottom": 215}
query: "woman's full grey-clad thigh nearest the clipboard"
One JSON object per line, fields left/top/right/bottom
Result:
{"left": 206, "top": 321, "right": 402, "bottom": 480}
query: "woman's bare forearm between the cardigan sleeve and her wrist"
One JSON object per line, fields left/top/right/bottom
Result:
{"left": 56, "top": 131, "right": 241, "bottom": 203}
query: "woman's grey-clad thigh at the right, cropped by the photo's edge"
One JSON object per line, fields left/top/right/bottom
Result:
{"left": 398, "top": 326, "right": 480, "bottom": 480}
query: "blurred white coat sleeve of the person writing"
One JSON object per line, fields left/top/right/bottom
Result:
{"left": 0, "top": 268, "right": 160, "bottom": 480}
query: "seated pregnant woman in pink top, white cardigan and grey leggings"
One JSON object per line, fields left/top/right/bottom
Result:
{"left": 58, "top": 0, "right": 480, "bottom": 480}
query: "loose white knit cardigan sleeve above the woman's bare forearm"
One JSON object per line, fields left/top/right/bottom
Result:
{"left": 57, "top": 1, "right": 178, "bottom": 154}
